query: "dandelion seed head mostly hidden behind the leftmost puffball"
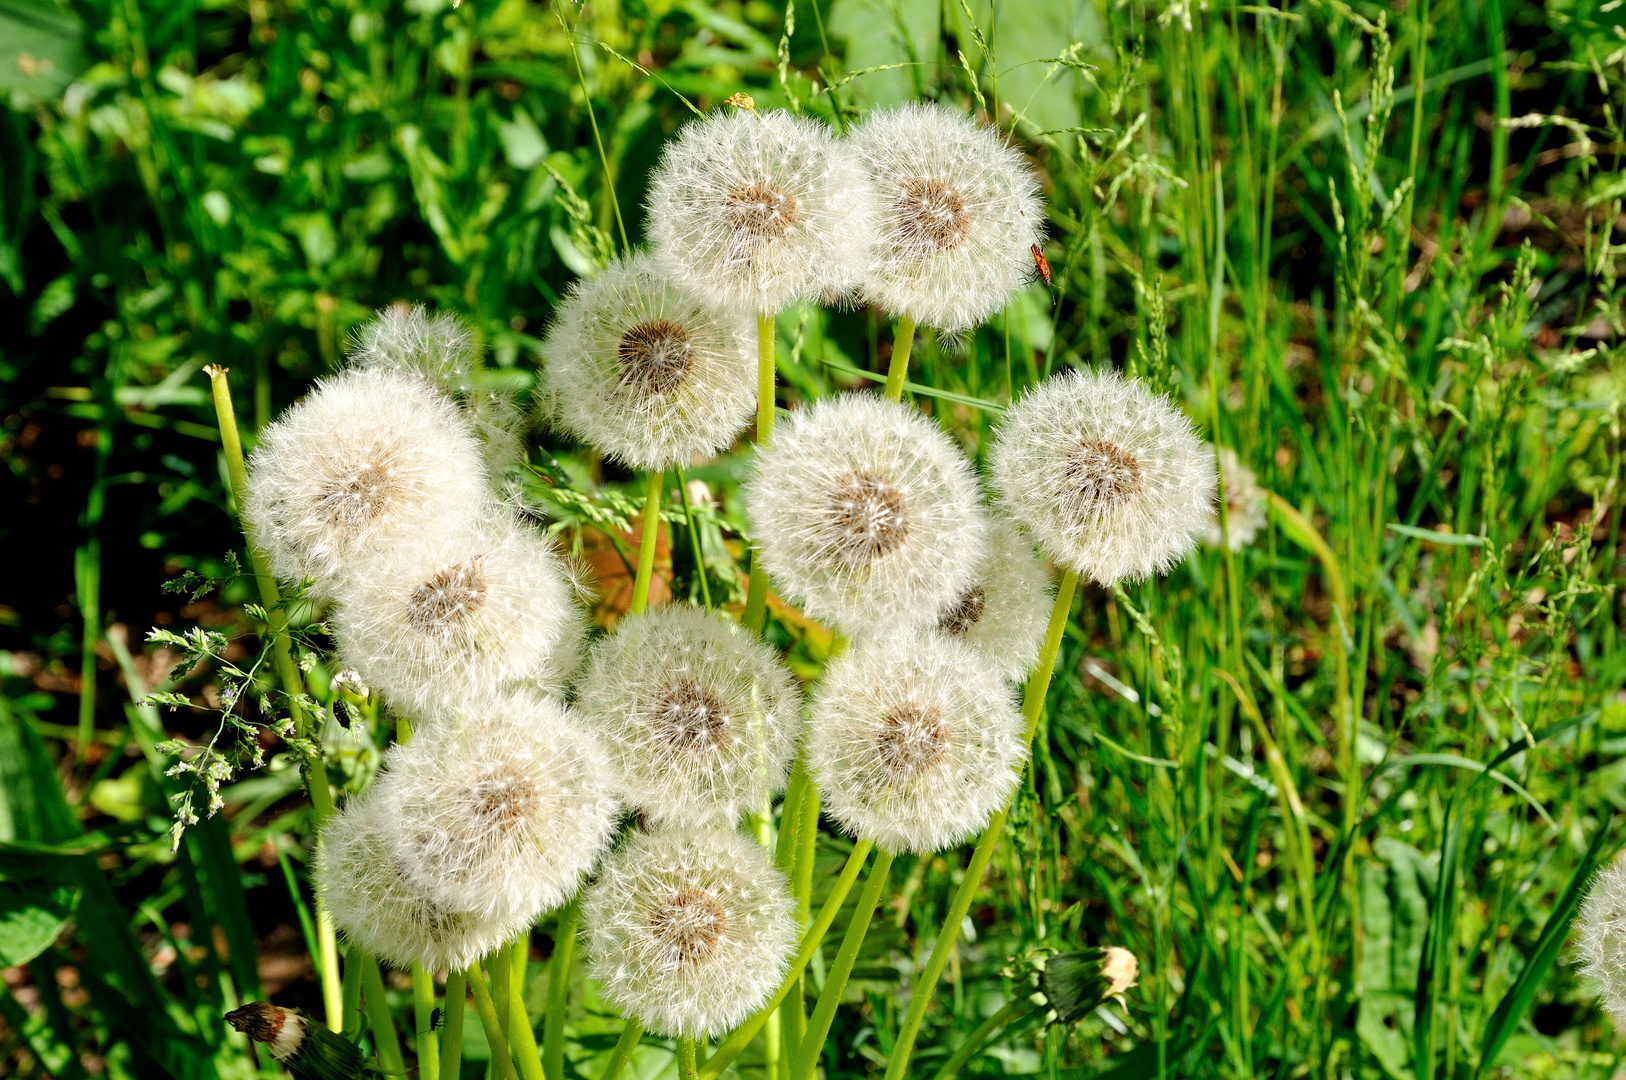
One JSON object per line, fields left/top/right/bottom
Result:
{"left": 350, "top": 304, "right": 525, "bottom": 475}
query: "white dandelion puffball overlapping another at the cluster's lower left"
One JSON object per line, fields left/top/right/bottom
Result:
{"left": 374, "top": 693, "right": 620, "bottom": 921}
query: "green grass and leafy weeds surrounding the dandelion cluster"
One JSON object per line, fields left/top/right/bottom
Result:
{"left": 0, "top": 0, "right": 1626, "bottom": 1080}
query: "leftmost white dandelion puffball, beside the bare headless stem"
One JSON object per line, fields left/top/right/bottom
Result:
{"left": 242, "top": 371, "right": 489, "bottom": 599}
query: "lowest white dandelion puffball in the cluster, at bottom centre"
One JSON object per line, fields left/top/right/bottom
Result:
{"left": 582, "top": 828, "right": 798, "bottom": 1038}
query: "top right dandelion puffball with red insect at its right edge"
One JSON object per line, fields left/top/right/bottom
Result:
{"left": 852, "top": 104, "right": 1044, "bottom": 333}
